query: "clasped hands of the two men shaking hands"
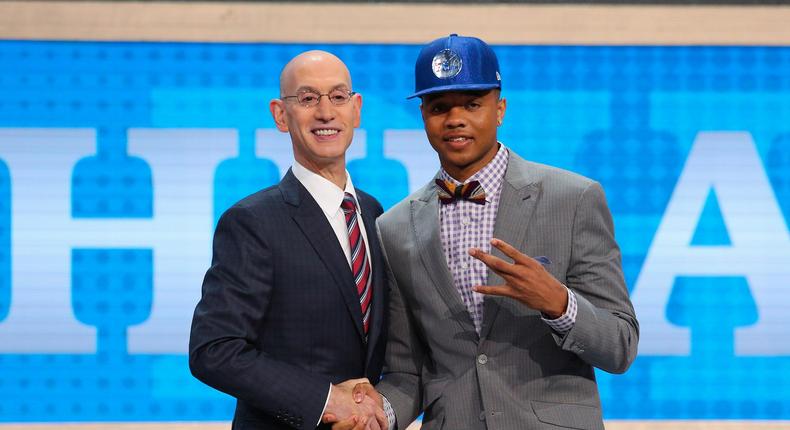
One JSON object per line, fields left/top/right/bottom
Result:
{"left": 321, "top": 378, "right": 389, "bottom": 430}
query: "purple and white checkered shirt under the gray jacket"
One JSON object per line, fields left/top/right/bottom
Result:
{"left": 439, "top": 144, "right": 576, "bottom": 334}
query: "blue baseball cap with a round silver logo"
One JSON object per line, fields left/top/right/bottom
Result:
{"left": 407, "top": 34, "right": 502, "bottom": 99}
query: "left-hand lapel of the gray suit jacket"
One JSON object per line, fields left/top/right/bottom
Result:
{"left": 411, "top": 182, "right": 475, "bottom": 332}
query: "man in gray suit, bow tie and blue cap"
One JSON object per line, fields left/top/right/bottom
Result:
{"left": 344, "top": 35, "right": 638, "bottom": 430}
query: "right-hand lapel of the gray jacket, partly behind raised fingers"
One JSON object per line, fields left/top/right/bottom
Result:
{"left": 480, "top": 151, "right": 541, "bottom": 338}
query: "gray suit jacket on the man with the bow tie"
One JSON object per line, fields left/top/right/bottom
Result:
{"left": 377, "top": 151, "right": 639, "bottom": 430}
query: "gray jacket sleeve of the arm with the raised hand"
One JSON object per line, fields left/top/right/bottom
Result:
{"left": 554, "top": 183, "right": 639, "bottom": 373}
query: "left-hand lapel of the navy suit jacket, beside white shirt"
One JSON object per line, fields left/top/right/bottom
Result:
{"left": 280, "top": 170, "right": 368, "bottom": 339}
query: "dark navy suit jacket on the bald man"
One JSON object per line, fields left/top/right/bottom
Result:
{"left": 189, "top": 170, "right": 387, "bottom": 429}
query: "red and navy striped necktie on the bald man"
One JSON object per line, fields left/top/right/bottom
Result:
{"left": 340, "top": 193, "right": 373, "bottom": 335}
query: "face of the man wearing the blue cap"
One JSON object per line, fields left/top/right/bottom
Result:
{"left": 420, "top": 90, "right": 506, "bottom": 181}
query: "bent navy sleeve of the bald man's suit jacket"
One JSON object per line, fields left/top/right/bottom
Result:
{"left": 189, "top": 207, "right": 330, "bottom": 428}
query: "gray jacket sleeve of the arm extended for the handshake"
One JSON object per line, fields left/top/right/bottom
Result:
{"left": 376, "top": 223, "right": 425, "bottom": 430}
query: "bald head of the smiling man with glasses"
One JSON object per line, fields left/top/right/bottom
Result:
{"left": 269, "top": 51, "right": 362, "bottom": 173}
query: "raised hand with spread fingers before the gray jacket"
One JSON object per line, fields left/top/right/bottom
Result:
{"left": 469, "top": 239, "right": 568, "bottom": 318}
